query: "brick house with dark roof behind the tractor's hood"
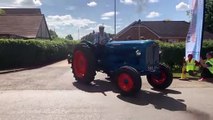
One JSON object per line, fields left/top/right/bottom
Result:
{"left": 116, "top": 20, "right": 213, "bottom": 42}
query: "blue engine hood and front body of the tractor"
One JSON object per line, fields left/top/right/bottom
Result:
{"left": 100, "top": 40, "right": 159, "bottom": 75}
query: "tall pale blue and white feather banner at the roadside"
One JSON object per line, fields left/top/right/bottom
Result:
{"left": 185, "top": 0, "right": 205, "bottom": 61}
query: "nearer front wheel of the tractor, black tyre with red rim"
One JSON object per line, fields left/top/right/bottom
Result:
{"left": 113, "top": 66, "right": 142, "bottom": 96}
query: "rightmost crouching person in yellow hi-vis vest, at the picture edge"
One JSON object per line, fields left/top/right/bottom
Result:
{"left": 199, "top": 51, "right": 213, "bottom": 81}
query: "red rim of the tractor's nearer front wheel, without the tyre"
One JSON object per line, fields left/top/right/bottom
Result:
{"left": 118, "top": 73, "right": 134, "bottom": 92}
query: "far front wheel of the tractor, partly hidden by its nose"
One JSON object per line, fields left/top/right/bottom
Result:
{"left": 147, "top": 64, "right": 173, "bottom": 90}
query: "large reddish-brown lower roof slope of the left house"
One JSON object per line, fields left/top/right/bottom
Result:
{"left": 0, "top": 15, "right": 44, "bottom": 38}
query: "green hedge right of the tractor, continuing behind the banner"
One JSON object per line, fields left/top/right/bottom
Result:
{"left": 158, "top": 40, "right": 213, "bottom": 70}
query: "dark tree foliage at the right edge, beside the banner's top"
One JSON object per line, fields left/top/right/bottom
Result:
{"left": 205, "top": 0, "right": 213, "bottom": 33}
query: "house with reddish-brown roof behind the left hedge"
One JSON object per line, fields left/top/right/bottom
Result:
{"left": 0, "top": 8, "right": 50, "bottom": 39}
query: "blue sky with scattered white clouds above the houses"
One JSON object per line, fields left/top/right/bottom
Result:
{"left": 0, "top": 0, "right": 190, "bottom": 39}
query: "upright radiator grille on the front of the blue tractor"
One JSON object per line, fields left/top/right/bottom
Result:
{"left": 146, "top": 44, "right": 159, "bottom": 70}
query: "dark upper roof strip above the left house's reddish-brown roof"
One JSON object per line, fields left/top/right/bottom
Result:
{"left": 2, "top": 8, "right": 42, "bottom": 15}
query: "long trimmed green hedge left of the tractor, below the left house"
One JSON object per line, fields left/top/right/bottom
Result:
{"left": 0, "top": 39, "right": 76, "bottom": 69}
